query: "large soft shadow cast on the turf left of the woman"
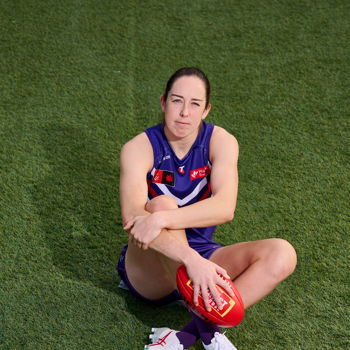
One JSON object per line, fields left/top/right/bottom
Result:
{"left": 33, "top": 124, "right": 125, "bottom": 292}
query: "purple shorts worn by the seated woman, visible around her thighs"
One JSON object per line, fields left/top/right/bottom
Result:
{"left": 117, "top": 242, "right": 221, "bottom": 306}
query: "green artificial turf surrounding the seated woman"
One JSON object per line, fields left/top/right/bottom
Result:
{"left": 0, "top": 0, "right": 350, "bottom": 350}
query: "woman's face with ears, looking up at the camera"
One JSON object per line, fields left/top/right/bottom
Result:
{"left": 160, "top": 75, "right": 210, "bottom": 139}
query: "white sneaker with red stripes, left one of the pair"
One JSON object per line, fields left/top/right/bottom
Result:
{"left": 144, "top": 328, "right": 184, "bottom": 350}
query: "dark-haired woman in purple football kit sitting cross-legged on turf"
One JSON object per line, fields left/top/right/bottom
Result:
{"left": 118, "top": 68, "right": 296, "bottom": 350}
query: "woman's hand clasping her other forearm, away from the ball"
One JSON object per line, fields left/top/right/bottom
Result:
{"left": 124, "top": 213, "right": 163, "bottom": 250}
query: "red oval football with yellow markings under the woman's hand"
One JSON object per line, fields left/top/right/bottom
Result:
{"left": 176, "top": 265, "right": 244, "bottom": 328}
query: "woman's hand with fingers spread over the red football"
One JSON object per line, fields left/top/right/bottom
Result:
{"left": 185, "top": 256, "right": 234, "bottom": 311}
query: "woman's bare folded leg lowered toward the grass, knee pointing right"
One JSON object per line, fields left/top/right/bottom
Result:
{"left": 210, "top": 238, "right": 297, "bottom": 308}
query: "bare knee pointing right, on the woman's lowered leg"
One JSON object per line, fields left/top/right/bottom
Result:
{"left": 267, "top": 238, "right": 297, "bottom": 282}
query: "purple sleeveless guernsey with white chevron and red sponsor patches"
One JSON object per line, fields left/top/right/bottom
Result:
{"left": 145, "top": 121, "right": 219, "bottom": 252}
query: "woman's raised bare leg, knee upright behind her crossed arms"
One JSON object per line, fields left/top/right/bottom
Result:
{"left": 125, "top": 196, "right": 188, "bottom": 300}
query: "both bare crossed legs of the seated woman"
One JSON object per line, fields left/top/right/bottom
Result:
{"left": 126, "top": 196, "right": 297, "bottom": 308}
